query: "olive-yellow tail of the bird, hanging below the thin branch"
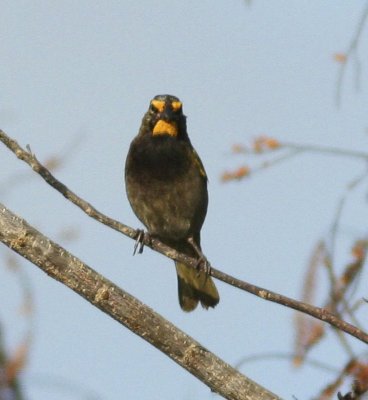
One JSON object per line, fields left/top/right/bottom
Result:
{"left": 175, "top": 261, "right": 220, "bottom": 312}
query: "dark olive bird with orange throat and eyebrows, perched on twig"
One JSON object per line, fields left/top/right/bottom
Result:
{"left": 125, "top": 94, "right": 219, "bottom": 312}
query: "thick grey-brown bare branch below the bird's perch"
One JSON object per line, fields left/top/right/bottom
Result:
{"left": 0, "top": 203, "right": 280, "bottom": 400}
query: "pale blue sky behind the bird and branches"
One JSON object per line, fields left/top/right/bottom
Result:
{"left": 0, "top": 0, "right": 368, "bottom": 400}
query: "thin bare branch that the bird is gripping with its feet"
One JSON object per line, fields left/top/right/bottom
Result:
{"left": 0, "top": 130, "right": 368, "bottom": 343}
